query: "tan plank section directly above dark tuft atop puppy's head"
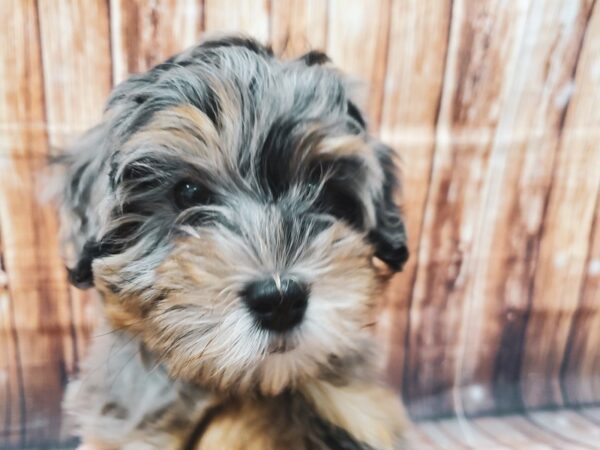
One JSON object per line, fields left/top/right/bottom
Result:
{"left": 271, "top": 0, "right": 327, "bottom": 58}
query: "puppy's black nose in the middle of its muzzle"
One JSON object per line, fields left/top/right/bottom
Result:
{"left": 242, "top": 278, "right": 310, "bottom": 332}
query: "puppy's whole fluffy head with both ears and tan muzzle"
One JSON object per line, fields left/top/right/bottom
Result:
{"left": 62, "top": 38, "right": 408, "bottom": 394}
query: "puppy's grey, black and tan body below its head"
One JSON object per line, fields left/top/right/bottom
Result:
{"left": 65, "top": 331, "right": 405, "bottom": 450}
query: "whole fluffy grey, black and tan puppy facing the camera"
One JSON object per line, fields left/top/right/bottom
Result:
{"left": 60, "top": 37, "right": 408, "bottom": 450}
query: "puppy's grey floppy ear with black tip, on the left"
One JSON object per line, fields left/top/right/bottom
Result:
{"left": 53, "top": 123, "right": 109, "bottom": 288}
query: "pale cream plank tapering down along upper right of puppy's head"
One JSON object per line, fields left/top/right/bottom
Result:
{"left": 327, "top": 0, "right": 392, "bottom": 131}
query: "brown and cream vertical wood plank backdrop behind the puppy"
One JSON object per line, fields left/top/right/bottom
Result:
{"left": 0, "top": 0, "right": 600, "bottom": 448}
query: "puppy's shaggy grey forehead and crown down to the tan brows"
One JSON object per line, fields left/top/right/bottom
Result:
{"left": 104, "top": 41, "right": 378, "bottom": 200}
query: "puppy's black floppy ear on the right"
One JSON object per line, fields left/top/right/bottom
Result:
{"left": 369, "top": 144, "right": 409, "bottom": 272}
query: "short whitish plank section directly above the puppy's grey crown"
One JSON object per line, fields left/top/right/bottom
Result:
{"left": 204, "top": 0, "right": 270, "bottom": 43}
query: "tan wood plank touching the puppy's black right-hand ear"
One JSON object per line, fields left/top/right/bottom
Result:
{"left": 378, "top": 0, "right": 452, "bottom": 398}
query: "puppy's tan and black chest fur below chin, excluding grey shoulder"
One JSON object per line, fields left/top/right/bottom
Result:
{"left": 195, "top": 381, "right": 404, "bottom": 450}
